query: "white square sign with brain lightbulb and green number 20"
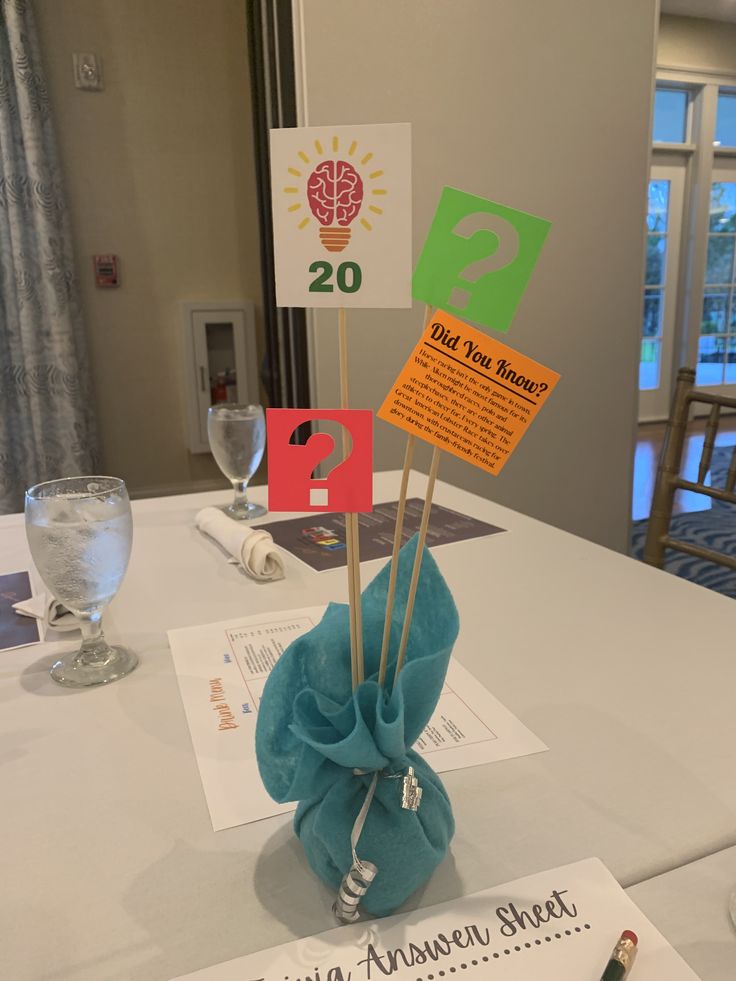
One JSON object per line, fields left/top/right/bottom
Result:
{"left": 271, "top": 123, "right": 411, "bottom": 307}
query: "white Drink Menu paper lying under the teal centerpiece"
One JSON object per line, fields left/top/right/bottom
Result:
{"left": 168, "top": 606, "right": 547, "bottom": 831}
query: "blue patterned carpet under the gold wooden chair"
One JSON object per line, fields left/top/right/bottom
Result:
{"left": 631, "top": 446, "right": 736, "bottom": 598}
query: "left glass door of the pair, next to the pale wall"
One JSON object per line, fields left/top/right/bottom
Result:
{"left": 639, "top": 158, "right": 686, "bottom": 420}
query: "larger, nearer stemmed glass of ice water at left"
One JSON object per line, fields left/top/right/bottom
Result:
{"left": 26, "top": 477, "right": 138, "bottom": 688}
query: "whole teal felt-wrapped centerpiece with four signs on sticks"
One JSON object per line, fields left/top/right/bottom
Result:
{"left": 256, "top": 124, "right": 558, "bottom": 922}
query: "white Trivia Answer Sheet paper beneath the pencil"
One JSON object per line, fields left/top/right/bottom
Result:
{"left": 168, "top": 858, "right": 698, "bottom": 981}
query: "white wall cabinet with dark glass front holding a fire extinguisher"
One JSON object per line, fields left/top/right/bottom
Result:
{"left": 182, "top": 300, "right": 260, "bottom": 453}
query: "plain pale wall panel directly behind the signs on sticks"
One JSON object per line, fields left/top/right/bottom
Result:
{"left": 296, "top": 0, "right": 657, "bottom": 550}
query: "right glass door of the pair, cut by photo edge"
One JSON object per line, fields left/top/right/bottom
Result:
{"left": 695, "top": 158, "right": 736, "bottom": 390}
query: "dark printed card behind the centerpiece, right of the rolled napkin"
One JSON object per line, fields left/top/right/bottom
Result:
{"left": 260, "top": 497, "right": 505, "bottom": 572}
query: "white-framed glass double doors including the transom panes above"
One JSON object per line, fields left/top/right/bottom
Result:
{"left": 639, "top": 78, "right": 736, "bottom": 419}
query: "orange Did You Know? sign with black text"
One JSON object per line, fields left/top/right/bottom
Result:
{"left": 378, "top": 310, "right": 560, "bottom": 474}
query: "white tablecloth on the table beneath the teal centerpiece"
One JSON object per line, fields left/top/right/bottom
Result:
{"left": 0, "top": 473, "right": 736, "bottom": 981}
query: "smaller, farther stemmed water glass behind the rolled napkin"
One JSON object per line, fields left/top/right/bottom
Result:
{"left": 207, "top": 402, "right": 266, "bottom": 521}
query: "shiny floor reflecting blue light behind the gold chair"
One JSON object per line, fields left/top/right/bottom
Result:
{"left": 631, "top": 416, "right": 736, "bottom": 521}
